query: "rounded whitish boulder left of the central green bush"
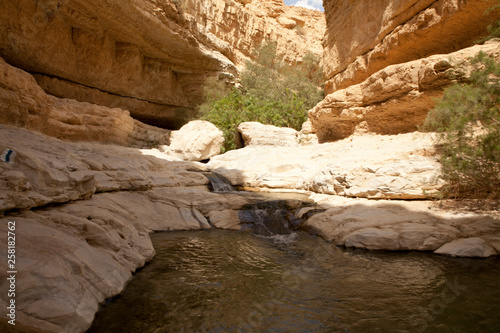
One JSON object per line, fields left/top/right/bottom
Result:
{"left": 162, "top": 120, "right": 224, "bottom": 161}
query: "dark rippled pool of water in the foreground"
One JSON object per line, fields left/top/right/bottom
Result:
{"left": 90, "top": 230, "right": 500, "bottom": 333}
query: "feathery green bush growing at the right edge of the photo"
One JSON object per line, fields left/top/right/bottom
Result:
{"left": 424, "top": 53, "right": 500, "bottom": 198}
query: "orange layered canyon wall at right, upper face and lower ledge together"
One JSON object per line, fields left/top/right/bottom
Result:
{"left": 309, "top": 0, "right": 500, "bottom": 142}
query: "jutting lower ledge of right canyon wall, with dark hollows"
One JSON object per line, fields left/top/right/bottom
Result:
{"left": 309, "top": 40, "right": 500, "bottom": 142}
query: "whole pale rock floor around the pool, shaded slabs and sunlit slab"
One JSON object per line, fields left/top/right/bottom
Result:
{"left": 0, "top": 126, "right": 500, "bottom": 332}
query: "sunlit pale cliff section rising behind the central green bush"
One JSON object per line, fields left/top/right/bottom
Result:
{"left": 183, "top": 0, "right": 325, "bottom": 69}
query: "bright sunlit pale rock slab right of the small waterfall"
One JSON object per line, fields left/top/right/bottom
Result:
{"left": 208, "top": 133, "right": 442, "bottom": 199}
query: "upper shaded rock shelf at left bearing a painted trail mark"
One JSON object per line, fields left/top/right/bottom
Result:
{"left": 0, "top": 125, "right": 208, "bottom": 211}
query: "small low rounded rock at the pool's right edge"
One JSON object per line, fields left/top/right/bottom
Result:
{"left": 434, "top": 237, "right": 497, "bottom": 258}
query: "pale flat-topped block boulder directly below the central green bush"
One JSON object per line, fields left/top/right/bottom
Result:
{"left": 238, "top": 122, "right": 298, "bottom": 147}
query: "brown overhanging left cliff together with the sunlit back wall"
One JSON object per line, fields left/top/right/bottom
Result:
{"left": 0, "top": 0, "right": 324, "bottom": 128}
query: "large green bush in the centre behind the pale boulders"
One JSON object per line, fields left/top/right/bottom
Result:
{"left": 199, "top": 43, "right": 323, "bottom": 151}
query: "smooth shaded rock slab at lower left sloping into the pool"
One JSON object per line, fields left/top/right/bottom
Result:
{"left": 0, "top": 186, "right": 247, "bottom": 332}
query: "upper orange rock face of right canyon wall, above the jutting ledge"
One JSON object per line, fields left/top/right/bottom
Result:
{"left": 324, "top": 0, "right": 500, "bottom": 94}
